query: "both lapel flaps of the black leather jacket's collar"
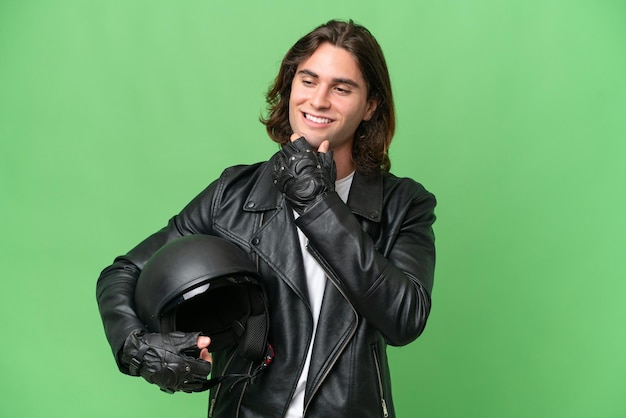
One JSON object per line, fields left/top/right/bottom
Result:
{"left": 244, "top": 158, "right": 383, "bottom": 222}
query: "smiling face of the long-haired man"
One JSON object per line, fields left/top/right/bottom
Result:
{"left": 289, "top": 43, "right": 377, "bottom": 156}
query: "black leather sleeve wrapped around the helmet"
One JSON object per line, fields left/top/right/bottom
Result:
{"left": 96, "top": 183, "right": 216, "bottom": 373}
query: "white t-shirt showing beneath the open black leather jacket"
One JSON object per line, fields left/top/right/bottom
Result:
{"left": 285, "top": 172, "right": 354, "bottom": 418}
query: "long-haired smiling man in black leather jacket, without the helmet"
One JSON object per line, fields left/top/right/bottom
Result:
{"left": 97, "top": 21, "right": 435, "bottom": 418}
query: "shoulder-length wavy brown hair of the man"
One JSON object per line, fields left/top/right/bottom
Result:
{"left": 261, "top": 20, "right": 396, "bottom": 174}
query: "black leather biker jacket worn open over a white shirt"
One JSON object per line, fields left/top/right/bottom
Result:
{"left": 97, "top": 155, "right": 435, "bottom": 418}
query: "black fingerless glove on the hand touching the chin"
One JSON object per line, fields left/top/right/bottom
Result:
{"left": 274, "top": 137, "right": 337, "bottom": 214}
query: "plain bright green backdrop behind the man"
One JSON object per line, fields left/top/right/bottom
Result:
{"left": 0, "top": 0, "right": 626, "bottom": 418}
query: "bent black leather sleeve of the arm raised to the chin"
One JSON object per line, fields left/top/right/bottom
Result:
{"left": 296, "top": 181, "right": 436, "bottom": 345}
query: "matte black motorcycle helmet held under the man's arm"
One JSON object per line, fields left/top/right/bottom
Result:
{"left": 135, "top": 235, "right": 269, "bottom": 361}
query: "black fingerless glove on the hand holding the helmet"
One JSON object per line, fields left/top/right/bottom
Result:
{"left": 121, "top": 332, "right": 211, "bottom": 393}
